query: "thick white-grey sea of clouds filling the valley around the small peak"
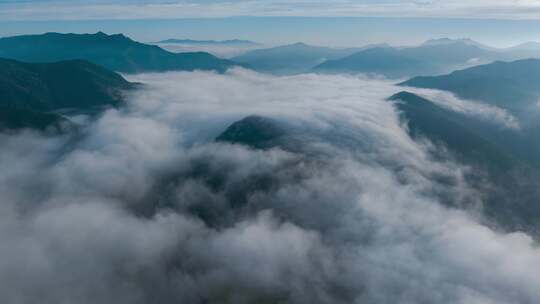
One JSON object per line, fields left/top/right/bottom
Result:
{"left": 0, "top": 70, "right": 540, "bottom": 303}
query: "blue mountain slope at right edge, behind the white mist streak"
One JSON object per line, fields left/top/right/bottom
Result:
{"left": 401, "top": 59, "right": 540, "bottom": 166}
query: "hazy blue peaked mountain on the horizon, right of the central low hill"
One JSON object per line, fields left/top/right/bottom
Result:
{"left": 314, "top": 39, "right": 509, "bottom": 78}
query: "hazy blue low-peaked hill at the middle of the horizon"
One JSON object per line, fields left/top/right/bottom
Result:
{"left": 232, "top": 43, "right": 368, "bottom": 74}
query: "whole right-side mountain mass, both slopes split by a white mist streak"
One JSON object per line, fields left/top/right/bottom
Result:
{"left": 390, "top": 59, "right": 540, "bottom": 229}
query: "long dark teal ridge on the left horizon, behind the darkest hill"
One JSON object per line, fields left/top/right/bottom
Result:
{"left": 0, "top": 32, "right": 240, "bottom": 73}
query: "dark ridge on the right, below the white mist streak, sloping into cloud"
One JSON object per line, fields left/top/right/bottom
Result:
{"left": 390, "top": 92, "right": 540, "bottom": 231}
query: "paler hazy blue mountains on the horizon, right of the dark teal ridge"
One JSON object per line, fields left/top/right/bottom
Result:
{"left": 232, "top": 38, "right": 540, "bottom": 78}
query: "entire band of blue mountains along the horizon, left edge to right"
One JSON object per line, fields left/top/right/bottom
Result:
{"left": 4, "top": 32, "right": 540, "bottom": 78}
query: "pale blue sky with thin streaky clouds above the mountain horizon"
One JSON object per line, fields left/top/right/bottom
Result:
{"left": 0, "top": 0, "right": 540, "bottom": 46}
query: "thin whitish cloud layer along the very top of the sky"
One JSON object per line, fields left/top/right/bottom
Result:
{"left": 0, "top": 0, "right": 540, "bottom": 21}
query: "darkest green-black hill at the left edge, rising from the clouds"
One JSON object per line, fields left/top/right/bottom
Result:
{"left": 0, "top": 59, "right": 135, "bottom": 130}
